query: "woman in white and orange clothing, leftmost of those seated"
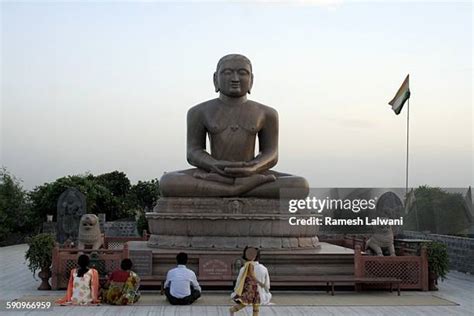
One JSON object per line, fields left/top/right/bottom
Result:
{"left": 56, "top": 255, "right": 100, "bottom": 305}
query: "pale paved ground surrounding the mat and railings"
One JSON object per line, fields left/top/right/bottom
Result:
{"left": 0, "top": 245, "right": 474, "bottom": 316}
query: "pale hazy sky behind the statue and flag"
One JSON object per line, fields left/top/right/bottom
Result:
{"left": 0, "top": 0, "right": 474, "bottom": 189}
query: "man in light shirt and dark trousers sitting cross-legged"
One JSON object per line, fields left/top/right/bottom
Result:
{"left": 165, "top": 252, "right": 201, "bottom": 305}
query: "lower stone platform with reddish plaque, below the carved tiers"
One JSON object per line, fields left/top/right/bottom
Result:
{"left": 128, "top": 241, "right": 354, "bottom": 285}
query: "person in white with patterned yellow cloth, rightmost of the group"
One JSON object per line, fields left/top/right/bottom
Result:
{"left": 230, "top": 247, "right": 272, "bottom": 316}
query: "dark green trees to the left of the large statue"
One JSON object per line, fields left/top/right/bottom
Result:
{"left": 0, "top": 168, "right": 159, "bottom": 245}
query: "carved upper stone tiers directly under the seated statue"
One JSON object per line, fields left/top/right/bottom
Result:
{"left": 146, "top": 198, "right": 319, "bottom": 250}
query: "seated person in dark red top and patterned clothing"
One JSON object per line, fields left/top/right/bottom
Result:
{"left": 102, "top": 258, "right": 140, "bottom": 305}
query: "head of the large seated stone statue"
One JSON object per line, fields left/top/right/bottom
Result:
{"left": 214, "top": 54, "right": 253, "bottom": 98}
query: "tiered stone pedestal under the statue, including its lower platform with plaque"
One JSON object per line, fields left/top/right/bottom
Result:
{"left": 142, "top": 198, "right": 354, "bottom": 286}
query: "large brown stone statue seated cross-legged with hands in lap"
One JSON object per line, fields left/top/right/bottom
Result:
{"left": 160, "top": 54, "right": 309, "bottom": 199}
